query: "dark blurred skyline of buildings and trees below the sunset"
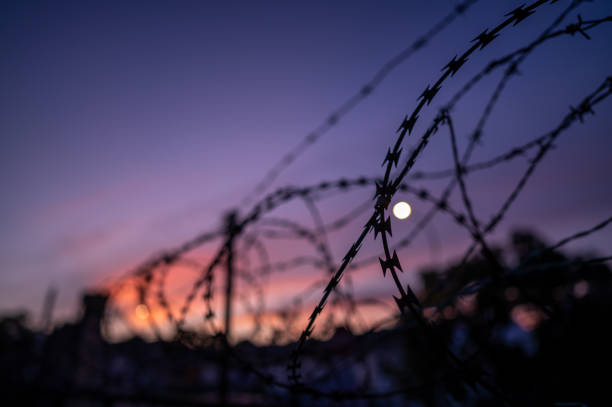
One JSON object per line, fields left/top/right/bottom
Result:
{"left": 0, "top": 232, "right": 612, "bottom": 407}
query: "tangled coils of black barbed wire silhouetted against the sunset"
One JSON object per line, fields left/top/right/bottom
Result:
{"left": 92, "top": 0, "right": 612, "bottom": 405}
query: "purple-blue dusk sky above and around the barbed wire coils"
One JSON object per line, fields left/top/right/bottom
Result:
{"left": 0, "top": 0, "right": 612, "bottom": 334}
